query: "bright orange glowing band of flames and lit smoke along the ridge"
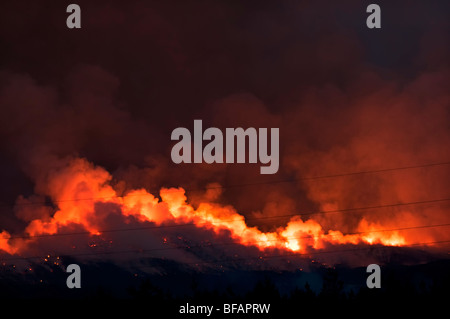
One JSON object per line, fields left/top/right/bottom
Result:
{"left": 0, "top": 158, "right": 442, "bottom": 262}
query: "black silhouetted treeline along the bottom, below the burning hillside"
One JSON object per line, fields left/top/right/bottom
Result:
{"left": 0, "top": 260, "right": 450, "bottom": 318}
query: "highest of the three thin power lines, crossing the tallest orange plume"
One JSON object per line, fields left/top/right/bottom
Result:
{"left": 0, "top": 161, "right": 450, "bottom": 207}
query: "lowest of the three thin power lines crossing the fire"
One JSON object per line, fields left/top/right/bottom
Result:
{"left": 1, "top": 223, "right": 450, "bottom": 261}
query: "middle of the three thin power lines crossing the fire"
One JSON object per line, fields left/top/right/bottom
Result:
{"left": 4, "top": 198, "right": 450, "bottom": 239}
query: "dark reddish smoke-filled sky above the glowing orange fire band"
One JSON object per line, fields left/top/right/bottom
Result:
{"left": 0, "top": 0, "right": 450, "bottom": 238}
